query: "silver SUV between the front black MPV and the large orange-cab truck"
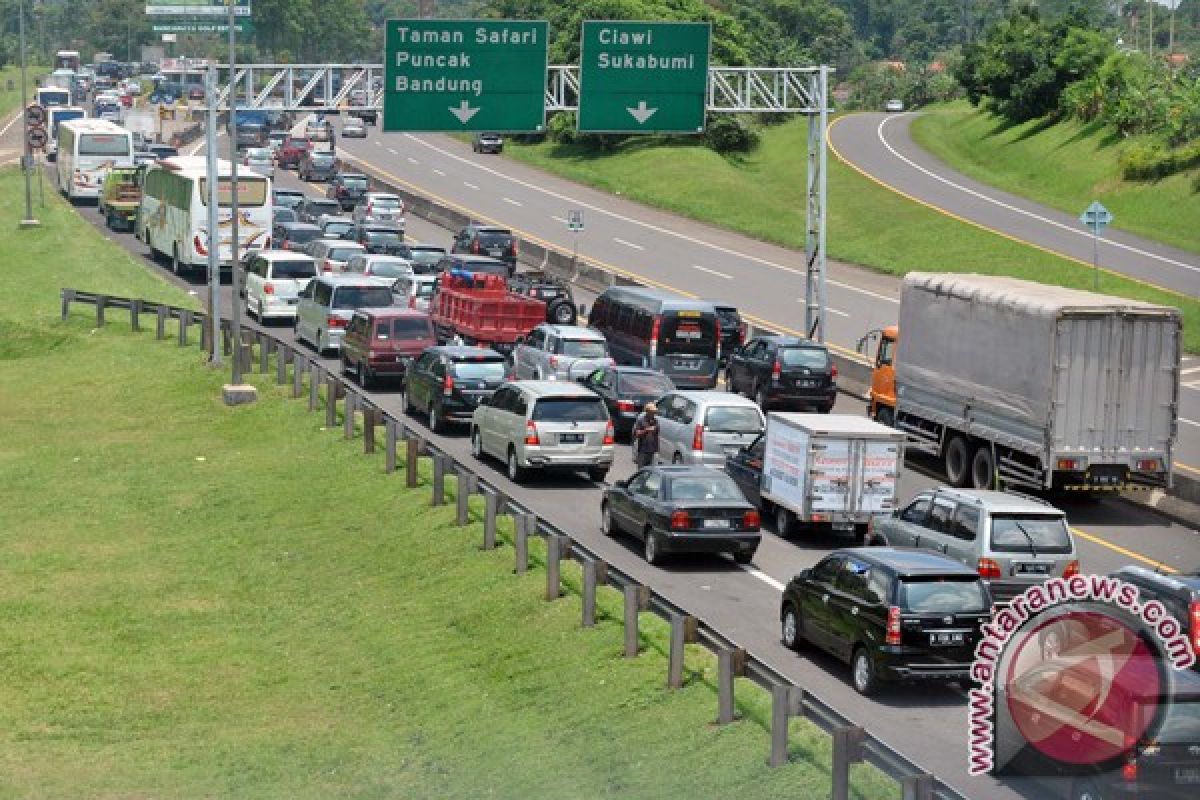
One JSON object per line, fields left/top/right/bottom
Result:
{"left": 866, "top": 487, "right": 1079, "bottom": 602}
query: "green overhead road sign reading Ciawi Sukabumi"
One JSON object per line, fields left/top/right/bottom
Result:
{"left": 578, "top": 20, "right": 712, "bottom": 133}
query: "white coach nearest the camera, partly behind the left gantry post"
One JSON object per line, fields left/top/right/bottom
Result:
{"left": 137, "top": 156, "right": 272, "bottom": 275}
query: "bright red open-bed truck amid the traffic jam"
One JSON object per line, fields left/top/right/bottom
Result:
{"left": 430, "top": 271, "right": 546, "bottom": 354}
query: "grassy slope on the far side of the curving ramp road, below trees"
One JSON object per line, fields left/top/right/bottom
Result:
{"left": 912, "top": 101, "right": 1200, "bottom": 253}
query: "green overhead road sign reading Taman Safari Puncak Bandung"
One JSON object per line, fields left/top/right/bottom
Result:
{"left": 383, "top": 19, "right": 548, "bottom": 133}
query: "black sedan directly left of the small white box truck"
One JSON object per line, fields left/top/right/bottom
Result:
{"left": 600, "top": 465, "right": 762, "bottom": 564}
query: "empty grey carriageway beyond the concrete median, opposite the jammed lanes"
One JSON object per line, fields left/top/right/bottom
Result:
{"left": 316, "top": 126, "right": 1200, "bottom": 479}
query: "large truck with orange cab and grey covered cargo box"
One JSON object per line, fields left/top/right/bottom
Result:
{"left": 860, "top": 272, "right": 1183, "bottom": 491}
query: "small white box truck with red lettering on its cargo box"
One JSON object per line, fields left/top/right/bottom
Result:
{"left": 725, "top": 411, "right": 905, "bottom": 536}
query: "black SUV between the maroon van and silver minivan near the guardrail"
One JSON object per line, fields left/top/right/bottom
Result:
{"left": 403, "top": 345, "right": 508, "bottom": 433}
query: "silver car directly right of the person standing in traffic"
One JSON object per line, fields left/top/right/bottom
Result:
{"left": 658, "top": 391, "right": 767, "bottom": 469}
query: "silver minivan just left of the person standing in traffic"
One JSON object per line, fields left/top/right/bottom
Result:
{"left": 470, "top": 380, "right": 614, "bottom": 483}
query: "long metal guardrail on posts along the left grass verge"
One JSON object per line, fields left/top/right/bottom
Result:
{"left": 61, "top": 288, "right": 967, "bottom": 800}
